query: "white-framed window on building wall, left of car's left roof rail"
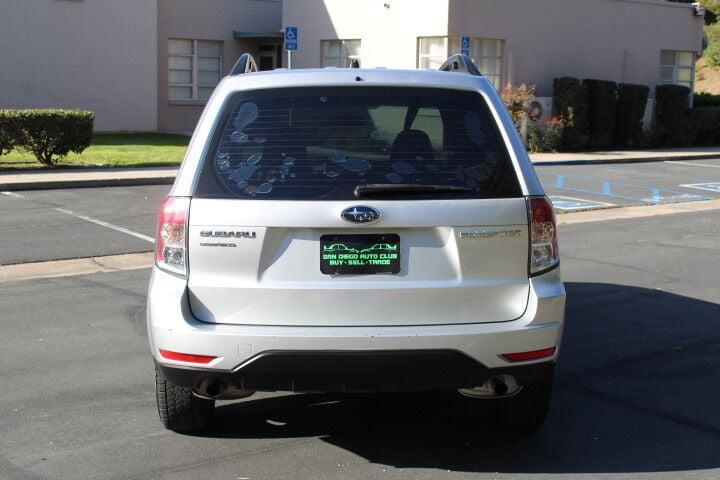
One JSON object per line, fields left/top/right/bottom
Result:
{"left": 168, "top": 38, "right": 223, "bottom": 100}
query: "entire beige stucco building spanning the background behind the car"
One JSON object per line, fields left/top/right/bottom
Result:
{"left": 0, "top": 0, "right": 703, "bottom": 132}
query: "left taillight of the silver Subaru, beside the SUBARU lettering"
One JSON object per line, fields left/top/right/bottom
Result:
{"left": 155, "top": 197, "right": 190, "bottom": 275}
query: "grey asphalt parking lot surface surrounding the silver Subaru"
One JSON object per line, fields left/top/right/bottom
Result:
{"left": 0, "top": 161, "right": 720, "bottom": 479}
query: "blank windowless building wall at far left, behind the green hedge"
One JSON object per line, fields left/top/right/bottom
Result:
{"left": 0, "top": 0, "right": 157, "bottom": 130}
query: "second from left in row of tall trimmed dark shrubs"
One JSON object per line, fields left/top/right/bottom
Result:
{"left": 583, "top": 79, "right": 617, "bottom": 150}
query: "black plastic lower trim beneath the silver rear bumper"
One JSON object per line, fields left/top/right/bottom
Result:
{"left": 157, "top": 350, "right": 552, "bottom": 393}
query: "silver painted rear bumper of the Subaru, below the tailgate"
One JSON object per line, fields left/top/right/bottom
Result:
{"left": 147, "top": 268, "right": 565, "bottom": 384}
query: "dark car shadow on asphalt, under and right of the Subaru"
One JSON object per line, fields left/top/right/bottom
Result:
{"left": 198, "top": 283, "right": 720, "bottom": 473}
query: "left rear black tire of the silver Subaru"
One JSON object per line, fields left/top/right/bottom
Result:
{"left": 155, "top": 371, "right": 215, "bottom": 433}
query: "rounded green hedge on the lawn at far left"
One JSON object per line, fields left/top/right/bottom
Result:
{"left": 0, "top": 109, "right": 95, "bottom": 166}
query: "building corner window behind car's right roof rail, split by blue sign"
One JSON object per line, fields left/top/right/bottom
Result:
{"left": 418, "top": 37, "right": 503, "bottom": 88}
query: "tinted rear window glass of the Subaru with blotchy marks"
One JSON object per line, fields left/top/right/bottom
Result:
{"left": 195, "top": 87, "right": 521, "bottom": 200}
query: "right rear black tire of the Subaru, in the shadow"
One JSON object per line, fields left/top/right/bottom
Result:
{"left": 487, "top": 369, "right": 553, "bottom": 433}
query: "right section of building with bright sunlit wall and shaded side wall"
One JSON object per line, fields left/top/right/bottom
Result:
{"left": 283, "top": 0, "right": 703, "bottom": 96}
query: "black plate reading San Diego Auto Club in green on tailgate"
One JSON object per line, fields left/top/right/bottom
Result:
{"left": 320, "top": 233, "right": 400, "bottom": 276}
